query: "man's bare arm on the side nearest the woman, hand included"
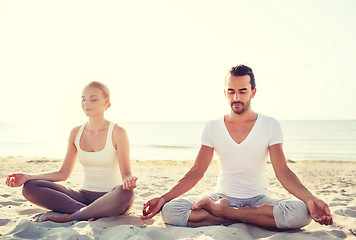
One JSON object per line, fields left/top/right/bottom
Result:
{"left": 141, "top": 145, "right": 214, "bottom": 220}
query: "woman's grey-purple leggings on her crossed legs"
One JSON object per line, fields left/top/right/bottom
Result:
{"left": 22, "top": 180, "right": 134, "bottom": 221}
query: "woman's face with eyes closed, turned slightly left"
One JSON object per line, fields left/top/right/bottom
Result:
{"left": 82, "top": 87, "right": 109, "bottom": 117}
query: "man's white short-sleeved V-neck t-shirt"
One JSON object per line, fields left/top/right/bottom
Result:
{"left": 201, "top": 114, "right": 283, "bottom": 198}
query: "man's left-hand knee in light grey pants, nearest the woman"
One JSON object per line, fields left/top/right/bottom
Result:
{"left": 161, "top": 199, "right": 194, "bottom": 226}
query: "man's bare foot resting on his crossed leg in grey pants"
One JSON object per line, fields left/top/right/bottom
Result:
{"left": 192, "top": 198, "right": 232, "bottom": 217}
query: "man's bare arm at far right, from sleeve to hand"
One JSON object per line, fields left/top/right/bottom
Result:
{"left": 269, "top": 144, "right": 333, "bottom": 225}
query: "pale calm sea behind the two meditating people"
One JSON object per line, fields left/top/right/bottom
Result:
{"left": 0, "top": 120, "right": 356, "bottom": 161}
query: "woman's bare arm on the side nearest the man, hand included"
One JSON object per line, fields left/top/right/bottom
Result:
{"left": 113, "top": 125, "right": 137, "bottom": 190}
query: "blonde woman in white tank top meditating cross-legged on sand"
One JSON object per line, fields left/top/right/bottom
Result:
{"left": 6, "top": 82, "right": 137, "bottom": 222}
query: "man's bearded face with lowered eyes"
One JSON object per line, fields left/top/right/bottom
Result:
{"left": 224, "top": 75, "right": 256, "bottom": 114}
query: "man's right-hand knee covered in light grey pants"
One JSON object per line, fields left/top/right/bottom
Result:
{"left": 273, "top": 201, "right": 311, "bottom": 229}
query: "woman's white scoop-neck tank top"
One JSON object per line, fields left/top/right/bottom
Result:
{"left": 75, "top": 122, "right": 122, "bottom": 192}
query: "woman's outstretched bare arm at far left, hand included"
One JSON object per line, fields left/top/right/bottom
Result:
{"left": 6, "top": 127, "right": 79, "bottom": 187}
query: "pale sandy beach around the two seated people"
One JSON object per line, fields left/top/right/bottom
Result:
{"left": 0, "top": 157, "right": 356, "bottom": 240}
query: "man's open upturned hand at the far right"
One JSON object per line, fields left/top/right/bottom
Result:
{"left": 307, "top": 198, "right": 333, "bottom": 225}
